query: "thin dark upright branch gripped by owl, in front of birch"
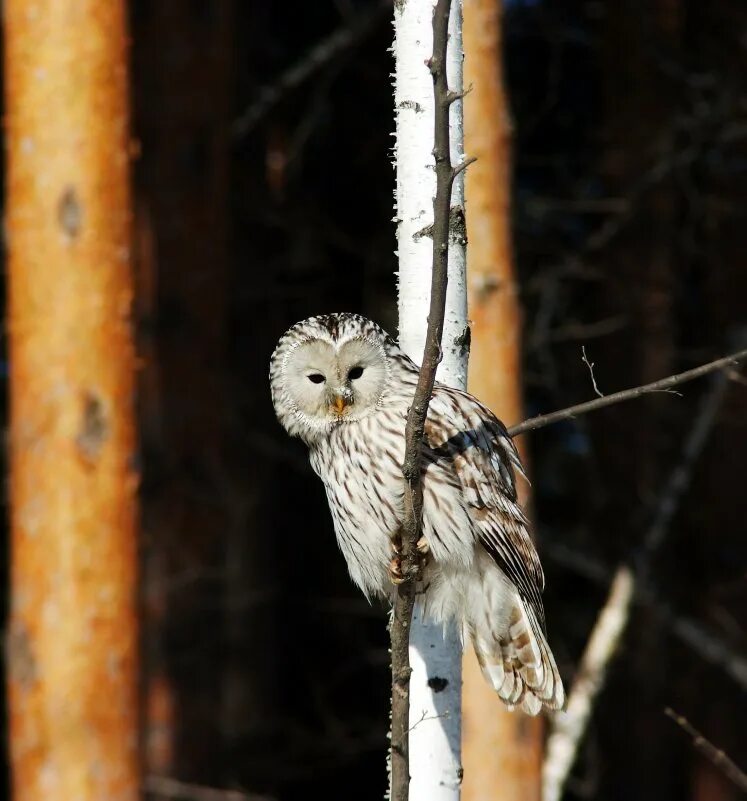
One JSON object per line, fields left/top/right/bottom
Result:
{"left": 390, "top": 0, "right": 455, "bottom": 801}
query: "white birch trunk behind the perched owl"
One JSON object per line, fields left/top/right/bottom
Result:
{"left": 394, "top": 0, "right": 467, "bottom": 801}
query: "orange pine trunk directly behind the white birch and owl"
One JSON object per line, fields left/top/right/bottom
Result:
{"left": 462, "top": 0, "right": 542, "bottom": 801}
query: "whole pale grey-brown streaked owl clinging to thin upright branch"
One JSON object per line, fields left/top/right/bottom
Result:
{"left": 270, "top": 314, "right": 564, "bottom": 715}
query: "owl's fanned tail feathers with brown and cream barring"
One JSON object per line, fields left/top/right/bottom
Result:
{"left": 466, "top": 577, "right": 565, "bottom": 715}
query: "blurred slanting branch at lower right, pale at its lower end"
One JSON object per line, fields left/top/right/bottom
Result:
{"left": 542, "top": 372, "right": 729, "bottom": 801}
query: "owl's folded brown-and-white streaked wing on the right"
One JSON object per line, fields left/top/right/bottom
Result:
{"left": 423, "top": 384, "right": 545, "bottom": 629}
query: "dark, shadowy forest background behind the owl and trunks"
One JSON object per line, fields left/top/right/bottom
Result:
{"left": 4, "top": 0, "right": 747, "bottom": 801}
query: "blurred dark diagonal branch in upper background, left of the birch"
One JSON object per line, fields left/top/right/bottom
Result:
{"left": 231, "top": 0, "right": 392, "bottom": 139}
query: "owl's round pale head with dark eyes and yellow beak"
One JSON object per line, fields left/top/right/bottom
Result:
{"left": 270, "top": 314, "right": 399, "bottom": 444}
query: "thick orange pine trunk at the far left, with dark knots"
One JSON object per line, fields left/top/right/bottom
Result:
{"left": 4, "top": 0, "right": 139, "bottom": 801}
